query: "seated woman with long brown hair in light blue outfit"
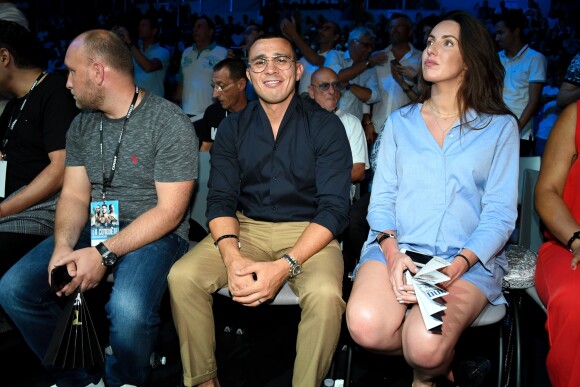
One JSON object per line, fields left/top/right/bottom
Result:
{"left": 346, "top": 12, "right": 519, "bottom": 387}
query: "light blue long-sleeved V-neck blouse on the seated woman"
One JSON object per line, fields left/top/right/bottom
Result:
{"left": 359, "top": 104, "right": 519, "bottom": 304}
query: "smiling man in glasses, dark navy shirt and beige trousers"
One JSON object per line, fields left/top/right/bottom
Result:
{"left": 168, "top": 36, "right": 352, "bottom": 386}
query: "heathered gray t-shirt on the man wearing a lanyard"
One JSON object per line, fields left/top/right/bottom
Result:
{"left": 66, "top": 93, "right": 199, "bottom": 240}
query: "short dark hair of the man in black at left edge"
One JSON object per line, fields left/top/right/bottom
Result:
{"left": 0, "top": 20, "right": 44, "bottom": 69}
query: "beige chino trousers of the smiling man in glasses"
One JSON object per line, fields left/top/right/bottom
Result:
{"left": 168, "top": 213, "right": 345, "bottom": 387}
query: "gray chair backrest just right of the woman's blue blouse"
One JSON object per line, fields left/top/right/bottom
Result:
{"left": 518, "top": 169, "right": 543, "bottom": 253}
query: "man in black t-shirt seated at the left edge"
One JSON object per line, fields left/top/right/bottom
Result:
{"left": 0, "top": 20, "right": 78, "bottom": 277}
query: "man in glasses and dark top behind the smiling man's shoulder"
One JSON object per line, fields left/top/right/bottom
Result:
{"left": 193, "top": 58, "right": 248, "bottom": 152}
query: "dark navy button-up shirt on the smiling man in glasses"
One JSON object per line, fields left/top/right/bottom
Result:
{"left": 206, "top": 95, "right": 352, "bottom": 236}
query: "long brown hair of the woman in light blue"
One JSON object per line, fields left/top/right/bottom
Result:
{"left": 418, "top": 11, "right": 517, "bottom": 121}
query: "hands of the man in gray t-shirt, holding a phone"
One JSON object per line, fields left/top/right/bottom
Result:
{"left": 48, "top": 247, "right": 107, "bottom": 297}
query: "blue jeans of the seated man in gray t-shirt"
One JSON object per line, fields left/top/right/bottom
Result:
{"left": 0, "top": 227, "right": 189, "bottom": 387}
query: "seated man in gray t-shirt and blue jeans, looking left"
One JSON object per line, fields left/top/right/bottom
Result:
{"left": 0, "top": 30, "right": 198, "bottom": 386}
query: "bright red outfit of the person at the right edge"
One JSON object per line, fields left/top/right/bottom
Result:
{"left": 535, "top": 101, "right": 580, "bottom": 387}
